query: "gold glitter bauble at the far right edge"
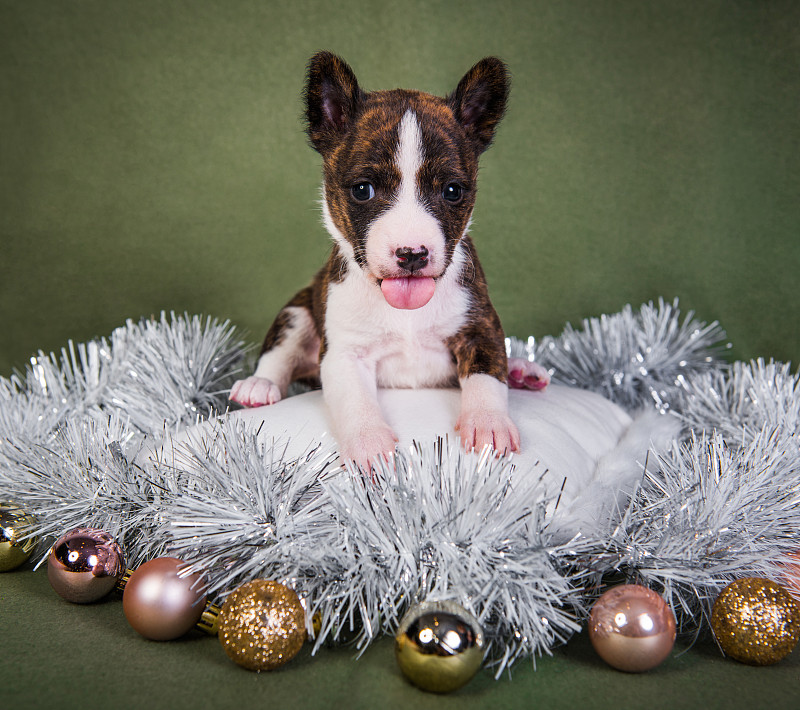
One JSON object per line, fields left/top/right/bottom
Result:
{"left": 711, "top": 577, "right": 800, "bottom": 666}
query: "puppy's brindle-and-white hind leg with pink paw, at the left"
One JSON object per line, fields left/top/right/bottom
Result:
{"left": 230, "top": 289, "right": 320, "bottom": 407}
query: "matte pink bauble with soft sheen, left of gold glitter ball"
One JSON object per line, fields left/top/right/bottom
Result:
{"left": 122, "top": 557, "right": 206, "bottom": 641}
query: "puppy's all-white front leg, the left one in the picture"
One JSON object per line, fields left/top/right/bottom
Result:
{"left": 320, "top": 351, "right": 397, "bottom": 473}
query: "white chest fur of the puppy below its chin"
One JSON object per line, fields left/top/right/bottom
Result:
{"left": 325, "top": 246, "right": 470, "bottom": 387}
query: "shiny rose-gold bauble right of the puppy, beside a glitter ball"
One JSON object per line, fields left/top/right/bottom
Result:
{"left": 589, "top": 584, "right": 675, "bottom": 673}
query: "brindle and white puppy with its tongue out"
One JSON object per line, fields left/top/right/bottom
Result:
{"left": 230, "top": 52, "right": 549, "bottom": 472}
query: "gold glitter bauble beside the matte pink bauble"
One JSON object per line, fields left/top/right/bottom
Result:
{"left": 218, "top": 579, "right": 306, "bottom": 671}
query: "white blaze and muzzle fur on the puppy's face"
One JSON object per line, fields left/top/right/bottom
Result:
{"left": 366, "top": 110, "right": 445, "bottom": 277}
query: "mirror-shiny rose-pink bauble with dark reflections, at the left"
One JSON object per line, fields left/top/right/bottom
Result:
{"left": 47, "top": 528, "right": 125, "bottom": 604}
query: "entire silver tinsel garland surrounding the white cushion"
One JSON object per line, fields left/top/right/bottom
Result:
{"left": 0, "top": 301, "right": 800, "bottom": 673}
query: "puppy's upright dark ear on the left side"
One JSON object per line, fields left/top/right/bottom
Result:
{"left": 305, "top": 52, "right": 364, "bottom": 155}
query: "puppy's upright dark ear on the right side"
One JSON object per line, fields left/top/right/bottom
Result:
{"left": 447, "top": 57, "right": 511, "bottom": 152}
